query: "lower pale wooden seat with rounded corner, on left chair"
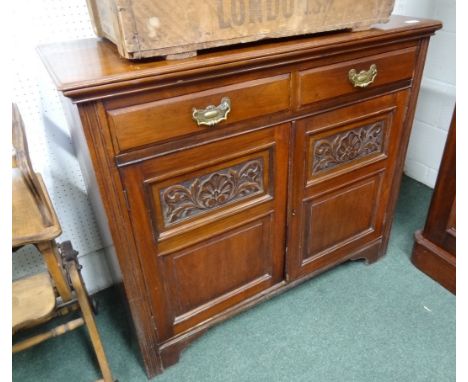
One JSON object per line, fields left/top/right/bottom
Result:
{"left": 12, "top": 273, "right": 56, "bottom": 333}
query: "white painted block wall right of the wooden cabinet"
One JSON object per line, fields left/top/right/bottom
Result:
{"left": 394, "top": 0, "right": 456, "bottom": 188}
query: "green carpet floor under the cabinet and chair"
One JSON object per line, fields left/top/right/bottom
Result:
{"left": 13, "top": 177, "right": 455, "bottom": 382}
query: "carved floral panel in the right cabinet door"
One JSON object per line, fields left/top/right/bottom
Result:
{"left": 312, "top": 121, "right": 385, "bottom": 174}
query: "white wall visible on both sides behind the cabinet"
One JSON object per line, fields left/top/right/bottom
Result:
{"left": 8, "top": 0, "right": 455, "bottom": 292}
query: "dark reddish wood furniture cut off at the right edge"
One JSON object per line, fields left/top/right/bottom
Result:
{"left": 411, "top": 107, "right": 456, "bottom": 294}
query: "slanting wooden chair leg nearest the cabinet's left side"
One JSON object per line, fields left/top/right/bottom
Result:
{"left": 64, "top": 245, "right": 114, "bottom": 382}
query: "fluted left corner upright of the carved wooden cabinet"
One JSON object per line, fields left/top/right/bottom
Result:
{"left": 65, "top": 100, "right": 162, "bottom": 377}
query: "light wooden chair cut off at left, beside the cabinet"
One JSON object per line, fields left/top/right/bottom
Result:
{"left": 12, "top": 105, "right": 113, "bottom": 382}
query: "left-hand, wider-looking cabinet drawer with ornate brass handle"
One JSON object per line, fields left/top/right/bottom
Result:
{"left": 108, "top": 73, "right": 290, "bottom": 152}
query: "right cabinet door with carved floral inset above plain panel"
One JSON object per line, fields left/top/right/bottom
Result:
{"left": 287, "top": 91, "right": 408, "bottom": 279}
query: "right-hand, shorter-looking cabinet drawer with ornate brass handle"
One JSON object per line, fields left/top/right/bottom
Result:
{"left": 298, "top": 47, "right": 416, "bottom": 107}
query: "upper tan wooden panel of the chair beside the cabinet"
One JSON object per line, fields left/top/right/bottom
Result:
{"left": 11, "top": 168, "right": 62, "bottom": 248}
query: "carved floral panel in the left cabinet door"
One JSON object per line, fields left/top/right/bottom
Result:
{"left": 160, "top": 158, "right": 264, "bottom": 226}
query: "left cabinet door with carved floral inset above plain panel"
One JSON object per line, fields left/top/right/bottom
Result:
{"left": 122, "top": 124, "right": 290, "bottom": 340}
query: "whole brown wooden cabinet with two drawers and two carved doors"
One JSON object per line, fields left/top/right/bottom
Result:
{"left": 39, "top": 17, "right": 441, "bottom": 376}
